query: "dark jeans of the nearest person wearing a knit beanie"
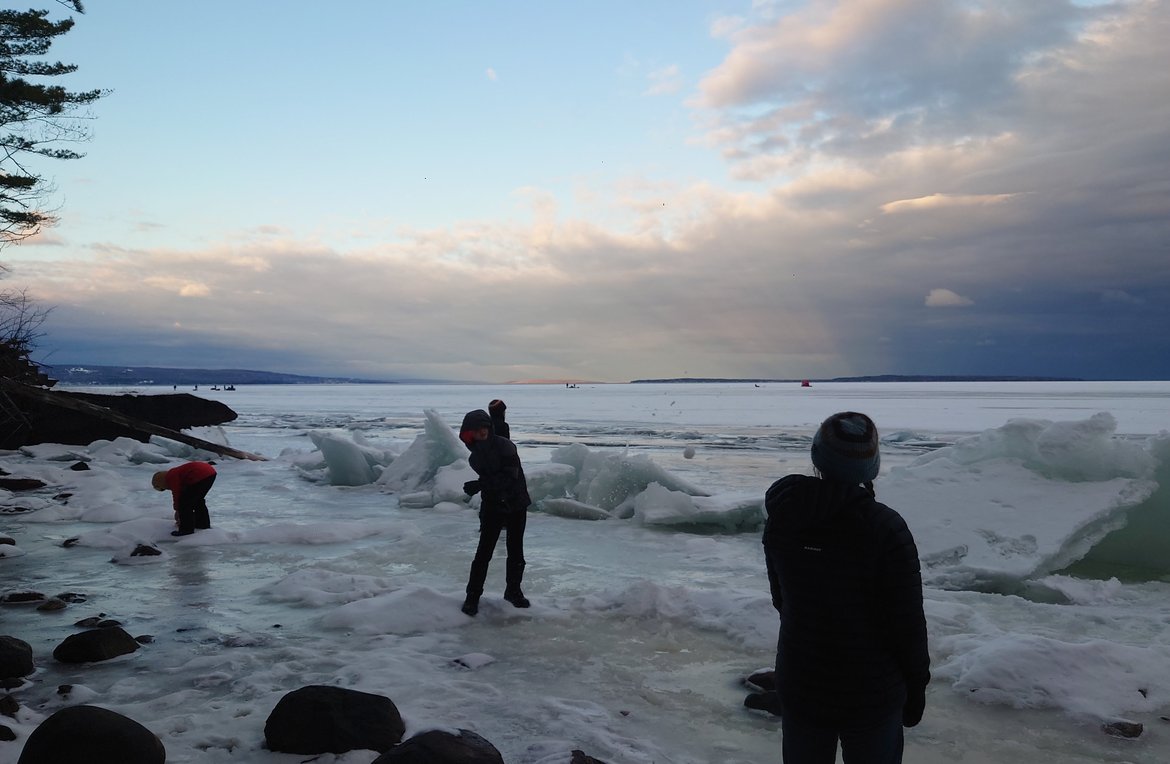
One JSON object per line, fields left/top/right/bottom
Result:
{"left": 782, "top": 708, "right": 903, "bottom": 764}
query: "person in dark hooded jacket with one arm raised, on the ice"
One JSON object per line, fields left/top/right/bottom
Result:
{"left": 459, "top": 408, "right": 532, "bottom": 615}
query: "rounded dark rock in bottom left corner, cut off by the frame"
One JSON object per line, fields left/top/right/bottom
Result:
{"left": 16, "top": 706, "right": 166, "bottom": 764}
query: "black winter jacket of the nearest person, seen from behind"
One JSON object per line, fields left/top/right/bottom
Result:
{"left": 764, "top": 475, "right": 930, "bottom": 727}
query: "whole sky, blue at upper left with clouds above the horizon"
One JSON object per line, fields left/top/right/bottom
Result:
{"left": 0, "top": 0, "right": 1170, "bottom": 381}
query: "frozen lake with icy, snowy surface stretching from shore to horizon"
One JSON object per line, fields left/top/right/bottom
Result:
{"left": 0, "top": 383, "right": 1170, "bottom": 764}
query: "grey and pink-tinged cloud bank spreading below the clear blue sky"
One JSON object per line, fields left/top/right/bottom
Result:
{"left": 5, "top": 0, "right": 1170, "bottom": 380}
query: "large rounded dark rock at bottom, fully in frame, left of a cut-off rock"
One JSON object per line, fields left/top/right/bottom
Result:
{"left": 264, "top": 684, "right": 406, "bottom": 753}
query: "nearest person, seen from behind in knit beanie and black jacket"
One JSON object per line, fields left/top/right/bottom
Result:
{"left": 763, "top": 412, "right": 930, "bottom": 764}
